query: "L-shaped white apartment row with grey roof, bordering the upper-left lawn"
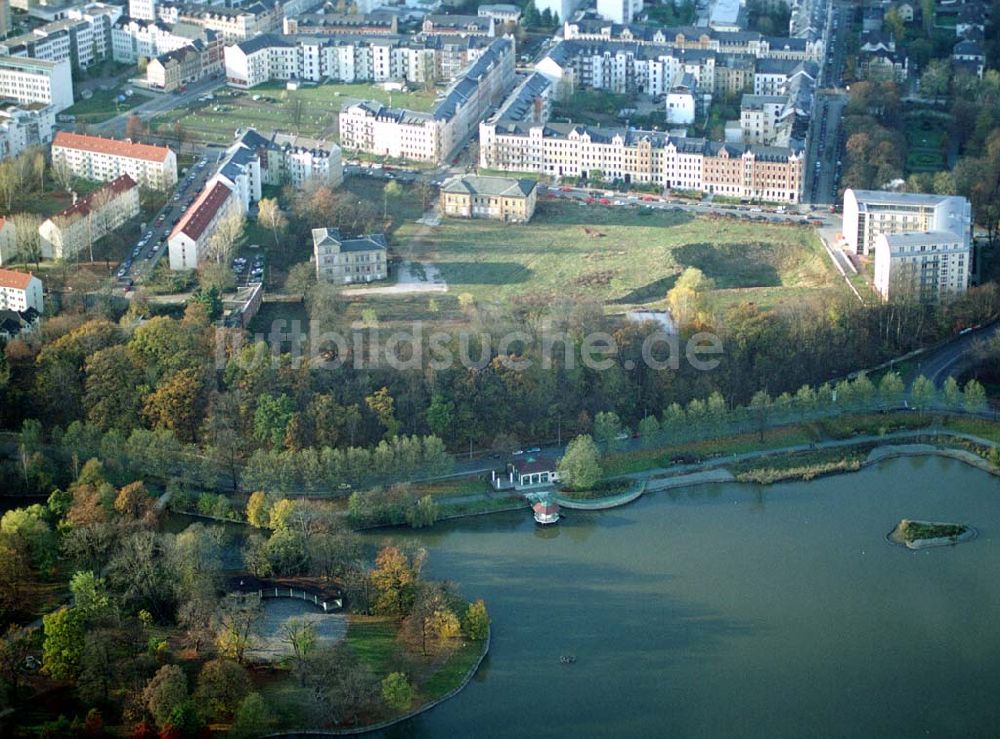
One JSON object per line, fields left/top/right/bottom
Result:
{"left": 340, "top": 38, "right": 514, "bottom": 163}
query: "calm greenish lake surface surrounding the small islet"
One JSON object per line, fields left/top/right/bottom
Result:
{"left": 378, "top": 458, "right": 1000, "bottom": 737}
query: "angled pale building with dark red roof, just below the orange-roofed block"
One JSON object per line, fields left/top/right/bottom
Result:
{"left": 38, "top": 174, "right": 139, "bottom": 259}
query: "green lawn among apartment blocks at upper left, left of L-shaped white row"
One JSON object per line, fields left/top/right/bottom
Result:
{"left": 150, "top": 83, "right": 437, "bottom": 142}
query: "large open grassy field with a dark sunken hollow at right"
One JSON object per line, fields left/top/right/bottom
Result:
{"left": 399, "top": 202, "right": 845, "bottom": 309}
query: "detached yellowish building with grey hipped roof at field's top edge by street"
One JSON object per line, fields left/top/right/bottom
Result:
{"left": 440, "top": 175, "right": 537, "bottom": 223}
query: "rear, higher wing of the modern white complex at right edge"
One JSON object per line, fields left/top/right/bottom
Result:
{"left": 843, "top": 189, "right": 972, "bottom": 254}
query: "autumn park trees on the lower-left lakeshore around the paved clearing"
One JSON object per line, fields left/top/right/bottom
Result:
{"left": 0, "top": 459, "right": 489, "bottom": 737}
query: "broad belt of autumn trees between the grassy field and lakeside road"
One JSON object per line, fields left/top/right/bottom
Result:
{"left": 0, "top": 285, "right": 1000, "bottom": 493}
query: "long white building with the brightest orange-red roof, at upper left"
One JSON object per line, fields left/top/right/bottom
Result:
{"left": 52, "top": 131, "right": 177, "bottom": 190}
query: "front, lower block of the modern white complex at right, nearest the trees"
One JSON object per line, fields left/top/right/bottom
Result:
{"left": 874, "top": 231, "right": 972, "bottom": 303}
